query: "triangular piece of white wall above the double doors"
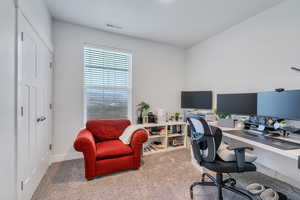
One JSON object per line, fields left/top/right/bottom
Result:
{"left": 17, "top": 0, "right": 53, "bottom": 50}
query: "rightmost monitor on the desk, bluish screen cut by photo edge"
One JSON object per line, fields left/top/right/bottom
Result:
{"left": 257, "top": 90, "right": 300, "bottom": 120}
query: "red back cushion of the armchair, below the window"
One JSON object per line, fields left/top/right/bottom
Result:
{"left": 86, "top": 119, "right": 130, "bottom": 141}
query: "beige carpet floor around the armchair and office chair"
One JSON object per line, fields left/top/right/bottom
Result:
{"left": 32, "top": 149, "right": 300, "bottom": 200}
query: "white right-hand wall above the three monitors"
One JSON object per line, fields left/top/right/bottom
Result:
{"left": 185, "top": 0, "right": 300, "bottom": 108}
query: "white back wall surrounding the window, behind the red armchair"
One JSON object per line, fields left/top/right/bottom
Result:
{"left": 53, "top": 21, "right": 184, "bottom": 161}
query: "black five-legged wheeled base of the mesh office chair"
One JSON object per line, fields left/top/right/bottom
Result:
{"left": 190, "top": 173, "right": 255, "bottom": 200}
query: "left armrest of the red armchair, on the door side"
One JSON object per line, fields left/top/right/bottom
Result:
{"left": 73, "top": 129, "right": 96, "bottom": 179}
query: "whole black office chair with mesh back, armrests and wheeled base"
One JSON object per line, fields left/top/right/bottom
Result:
{"left": 187, "top": 118, "right": 256, "bottom": 200}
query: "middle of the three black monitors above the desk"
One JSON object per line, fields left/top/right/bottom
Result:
{"left": 217, "top": 93, "right": 257, "bottom": 115}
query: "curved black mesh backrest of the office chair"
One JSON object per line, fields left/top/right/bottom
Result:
{"left": 187, "top": 118, "right": 222, "bottom": 164}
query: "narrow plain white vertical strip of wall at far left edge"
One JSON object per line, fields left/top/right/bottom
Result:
{"left": 0, "top": 0, "right": 16, "bottom": 200}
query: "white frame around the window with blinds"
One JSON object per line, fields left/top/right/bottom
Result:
{"left": 81, "top": 43, "right": 133, "bottom": 123}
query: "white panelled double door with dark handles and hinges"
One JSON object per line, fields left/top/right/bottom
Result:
{"left": 17, "top": 12, "right": 52, "bottom": 200}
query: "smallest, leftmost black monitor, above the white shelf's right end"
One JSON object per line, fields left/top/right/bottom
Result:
{"left": 181, "top": 91, "right": 212, "bottom": 109}
